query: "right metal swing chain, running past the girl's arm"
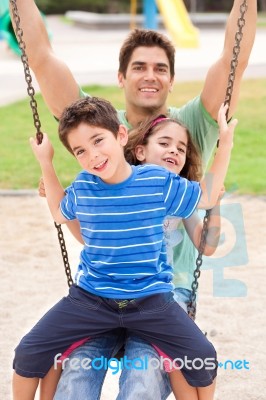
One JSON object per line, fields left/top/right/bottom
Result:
{"left": 187, "top": 0, "right": 248, "bottom": 320}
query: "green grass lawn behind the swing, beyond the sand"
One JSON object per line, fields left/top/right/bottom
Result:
{"left": 0, "top": 79, "right": 266, "bottom": 195}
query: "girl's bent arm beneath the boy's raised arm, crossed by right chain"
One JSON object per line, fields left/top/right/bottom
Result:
{"left": 183, "top": 190, "right": 224, "bottom": 256}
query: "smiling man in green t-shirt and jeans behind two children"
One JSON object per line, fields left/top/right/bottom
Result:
{"left": 11, "top": 0, "right": 257, "bottom": 400}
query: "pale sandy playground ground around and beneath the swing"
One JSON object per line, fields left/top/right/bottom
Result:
{"left": 0, "top": 195, "right": 266, "bottom": 400}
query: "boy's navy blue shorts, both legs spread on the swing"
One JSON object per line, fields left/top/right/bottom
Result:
{"left": 13, "top": 285, "right": 217, "bottom": 387}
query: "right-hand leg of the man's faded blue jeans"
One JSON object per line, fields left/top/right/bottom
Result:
{"left": 117, "top": 335, "right": 172, "bottom": 400}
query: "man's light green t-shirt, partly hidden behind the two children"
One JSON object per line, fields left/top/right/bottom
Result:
{"left": 81, "top": 91, "right": 218, "bottom": 290}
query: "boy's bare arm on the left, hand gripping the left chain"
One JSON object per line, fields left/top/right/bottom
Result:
{"left": 30, "top": 133, "right": 68, "bottom": 224}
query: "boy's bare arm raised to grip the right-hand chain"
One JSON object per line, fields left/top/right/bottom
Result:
{"left": 198, "top": 104, "right": 237, "bottom": 210}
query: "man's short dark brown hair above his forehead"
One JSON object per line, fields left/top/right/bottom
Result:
{"left": 119, "top": 29, "right": 175, "bottom": 78}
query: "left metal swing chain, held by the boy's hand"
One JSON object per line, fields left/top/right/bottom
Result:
{"left": 10, "top": 0, "right": 73, "bottom": 286}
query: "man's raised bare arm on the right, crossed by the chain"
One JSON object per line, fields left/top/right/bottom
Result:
{"left": 201, "top": 0, "right": 257, "bottom": 120}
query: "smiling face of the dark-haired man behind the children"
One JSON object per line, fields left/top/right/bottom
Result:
{"left": 118, "top": 46, "right": 173, "bottom": 112}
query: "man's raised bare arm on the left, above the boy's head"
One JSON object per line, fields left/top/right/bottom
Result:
{"left": 10, "top": 0, "right": 79, "bottom": 118}
